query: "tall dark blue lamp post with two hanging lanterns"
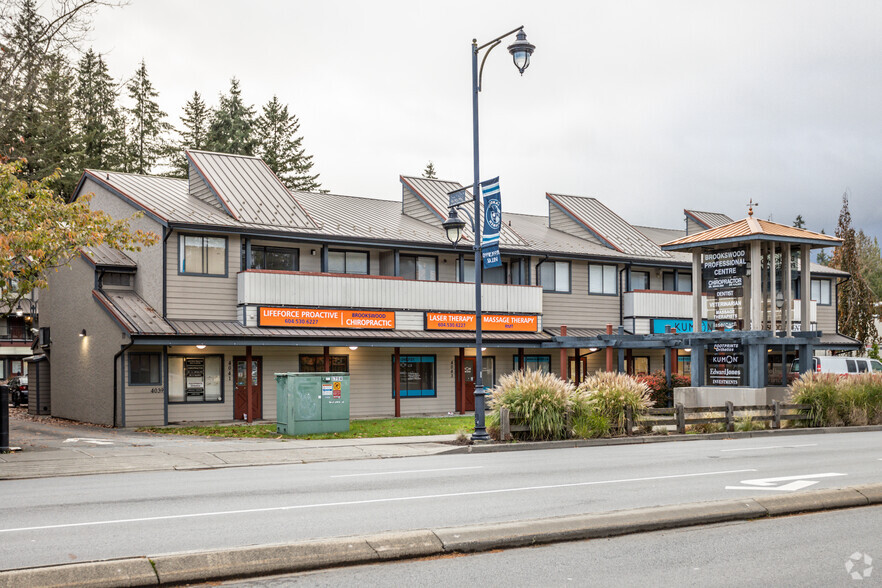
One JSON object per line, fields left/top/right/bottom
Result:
{"left": 442, "top": 26, "right": 536, "bottom": 441}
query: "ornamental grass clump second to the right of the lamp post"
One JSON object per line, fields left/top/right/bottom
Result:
{"left": 577, "top": 372, "right": 652, "bottom": 432}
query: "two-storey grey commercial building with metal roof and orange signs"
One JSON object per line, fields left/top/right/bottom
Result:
{"left": 41, "top": 151, "right": 848, "bottom": 427}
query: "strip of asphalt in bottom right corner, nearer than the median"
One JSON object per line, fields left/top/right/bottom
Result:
{"left": 223, "top": 506, "right": 882, "bottom": 588}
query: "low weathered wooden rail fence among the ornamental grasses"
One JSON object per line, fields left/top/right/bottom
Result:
{"left": 499, "top": 400, "right": 811, "bottom": 440}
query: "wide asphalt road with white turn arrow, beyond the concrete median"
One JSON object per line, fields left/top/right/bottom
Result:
{"left": 0, "top": 432, "right": 882, "bottom": 569}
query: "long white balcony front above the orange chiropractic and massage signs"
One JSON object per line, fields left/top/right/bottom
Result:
{"left": 238, "top": 270, "right": 542, "bottom": 314}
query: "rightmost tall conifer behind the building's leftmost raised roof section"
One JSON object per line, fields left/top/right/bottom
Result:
{"left": 255, "top": 96, "right": 321, "bottom": 192}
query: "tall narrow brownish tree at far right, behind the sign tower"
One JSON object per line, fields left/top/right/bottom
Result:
{"left": 830, "top": 194, "right": 877, "bottom": 344}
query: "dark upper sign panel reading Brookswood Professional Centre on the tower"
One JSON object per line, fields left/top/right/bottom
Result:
{"left": 701, "top": 247, "right": 748, "bottom": 331}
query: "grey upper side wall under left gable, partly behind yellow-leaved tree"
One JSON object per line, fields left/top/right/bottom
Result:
{"left": 81, "top": 177, "right": 162, "bottom": 310}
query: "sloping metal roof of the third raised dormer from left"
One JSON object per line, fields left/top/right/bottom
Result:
{"left": 545, "top": 193, "right": 670, "bottom": 259}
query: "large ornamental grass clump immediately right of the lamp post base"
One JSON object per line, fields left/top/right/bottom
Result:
{"left": 489, "top": 371, "right": 575, "bottom": 440}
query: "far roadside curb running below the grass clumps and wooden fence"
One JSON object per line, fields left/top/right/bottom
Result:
{"left": 439, "top": 425, "right": 882, "bottom": 455}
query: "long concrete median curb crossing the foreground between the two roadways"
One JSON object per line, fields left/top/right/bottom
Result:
{"left": 6, "top": 484, "right": 882, "bottom": 588}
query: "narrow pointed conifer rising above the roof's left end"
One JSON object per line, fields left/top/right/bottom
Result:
{"left": 126, "top": 59, "right": 172, "bottom": 174}
